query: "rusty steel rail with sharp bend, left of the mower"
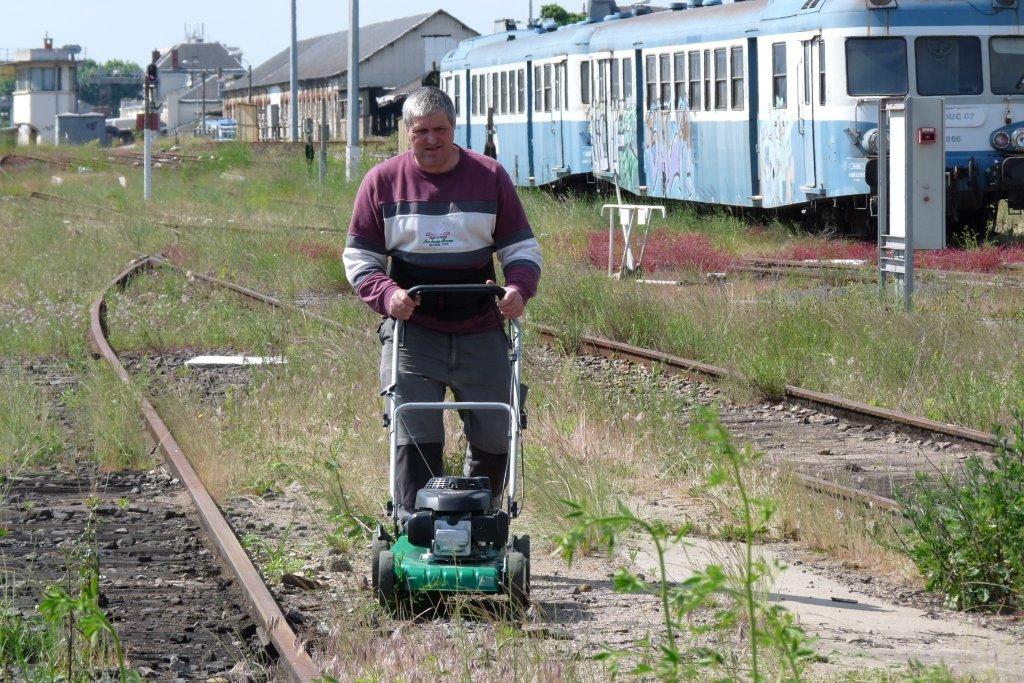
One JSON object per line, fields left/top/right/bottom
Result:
{"left": 89, "top": 256, "right": 321, "bottom": 681}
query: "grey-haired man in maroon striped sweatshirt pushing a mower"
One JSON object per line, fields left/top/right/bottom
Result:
{"left": 344, "top": 87, "right": 541, "bottom": 517}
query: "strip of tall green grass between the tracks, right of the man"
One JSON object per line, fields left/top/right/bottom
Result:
{"left": 534, "top": 269, "right": 1024, "bottom": 429}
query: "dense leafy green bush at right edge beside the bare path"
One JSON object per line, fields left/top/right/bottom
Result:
{"left": 897, "top": 409, "right": 1024, "bottom": 610}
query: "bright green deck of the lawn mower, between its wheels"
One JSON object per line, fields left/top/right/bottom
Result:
{"left": 391, "top": 535, "right": 503, "bottom": 593}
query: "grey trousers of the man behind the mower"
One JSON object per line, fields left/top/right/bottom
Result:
{"left": 379, "top": 318, "right": 512, "bottom": 511}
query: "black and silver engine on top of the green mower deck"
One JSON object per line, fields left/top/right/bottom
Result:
{"left": 406, "top": 476, "right": 509, "bottom": 561}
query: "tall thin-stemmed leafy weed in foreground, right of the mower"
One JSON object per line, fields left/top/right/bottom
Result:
{"left": 557, "top": 409, "right": 813, "bottom": 683}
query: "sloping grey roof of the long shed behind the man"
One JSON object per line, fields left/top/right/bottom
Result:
{"left": 230, "top": 9, "right": 451, "bottom": 91}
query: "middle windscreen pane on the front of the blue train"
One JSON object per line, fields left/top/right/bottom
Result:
{"left": 913, "top": 36, "right": 981, "bottom": 95}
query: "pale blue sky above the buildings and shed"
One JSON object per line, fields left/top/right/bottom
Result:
{"left": 0, "top": 0, "right": 584, "bottom": 67}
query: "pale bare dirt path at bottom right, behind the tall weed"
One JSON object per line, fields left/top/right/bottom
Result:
{"left": 635, "top": 539, "right": 1024, "bottom": 681}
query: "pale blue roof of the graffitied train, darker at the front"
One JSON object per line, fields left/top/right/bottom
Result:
{"left": 442, "top": 0, "right": 1024, "bottom": 70}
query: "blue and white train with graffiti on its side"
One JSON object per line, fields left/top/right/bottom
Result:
{"left": 441, "top": 0, "right": 1024, "bottom": 237}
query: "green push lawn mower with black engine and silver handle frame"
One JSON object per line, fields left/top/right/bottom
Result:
{"left": 372, "top": 285, "right": 529, "bottom": 615}
